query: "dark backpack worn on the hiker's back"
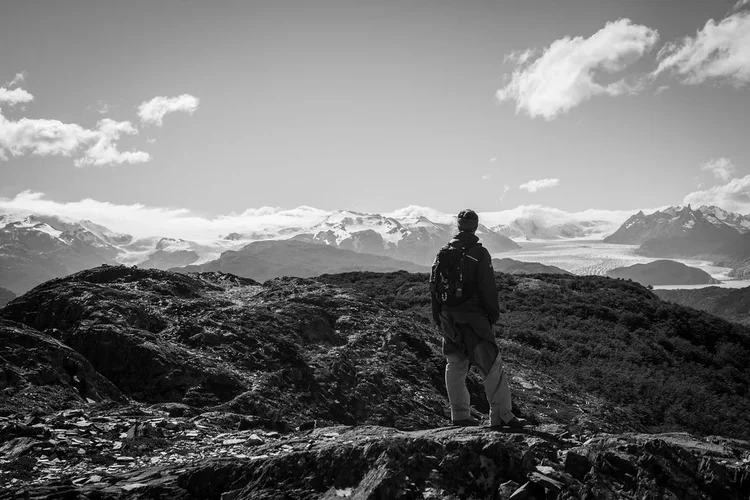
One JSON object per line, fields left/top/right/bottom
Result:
{"left": 430, "top": 243, "right": 482, "bottom": 307}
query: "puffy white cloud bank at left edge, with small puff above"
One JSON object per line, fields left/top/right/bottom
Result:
{"left": 0, "top": 88, "right": 151, "bottom": 166}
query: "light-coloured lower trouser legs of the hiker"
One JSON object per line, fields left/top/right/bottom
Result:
{"left": 445, "top": 354, "right": 515, "bottom": 425}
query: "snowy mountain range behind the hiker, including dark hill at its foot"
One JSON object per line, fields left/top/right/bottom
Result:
{"left": 0, "top": 211, "right": 520, "bottom": 293}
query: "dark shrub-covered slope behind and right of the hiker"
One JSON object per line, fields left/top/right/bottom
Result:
{"left": 320, "top": 272, "right": 750, "bottom": 439}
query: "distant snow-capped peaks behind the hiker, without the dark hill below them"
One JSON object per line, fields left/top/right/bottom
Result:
{"left": 0, "top": 207, "right": 520, "bottom": 293}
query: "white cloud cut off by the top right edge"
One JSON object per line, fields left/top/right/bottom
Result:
{"left": 653, "top": 10, "right": 750, "bottom": 87}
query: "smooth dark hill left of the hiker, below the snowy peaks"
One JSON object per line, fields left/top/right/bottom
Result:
{"left": 172, "top": 240, "right": 434, "bottom": 281}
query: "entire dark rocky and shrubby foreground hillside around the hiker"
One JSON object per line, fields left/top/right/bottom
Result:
{"left": 0, "top": 266, "right": 750, "bottom": 500}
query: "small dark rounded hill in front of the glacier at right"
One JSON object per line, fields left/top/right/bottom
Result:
{"left": 607, "top": 260, "right": 721, "bottom": 285}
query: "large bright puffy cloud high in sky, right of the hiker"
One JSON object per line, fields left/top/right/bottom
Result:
{"left": 496, "top": 19, "right": 659, "bottom": 120}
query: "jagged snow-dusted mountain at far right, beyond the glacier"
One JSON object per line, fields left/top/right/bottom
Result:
{"left": 604, "top": 205, "right": 748, "bottom": 257}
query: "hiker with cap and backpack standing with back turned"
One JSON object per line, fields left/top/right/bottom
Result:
{"left": 430, "top": 209, "right": 526, "bottom": 428}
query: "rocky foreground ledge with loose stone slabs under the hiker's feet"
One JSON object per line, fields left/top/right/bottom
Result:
{"left": 0, "top": 414, "right": 750, "bottom": 500}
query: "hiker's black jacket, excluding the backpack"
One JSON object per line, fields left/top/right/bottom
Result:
{"left": 431, "top": 231, "right": 500, "bottom": 325}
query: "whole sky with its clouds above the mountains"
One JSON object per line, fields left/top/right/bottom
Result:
{"left": 0, "top": 0, "right": 750, "bottom": 236}
